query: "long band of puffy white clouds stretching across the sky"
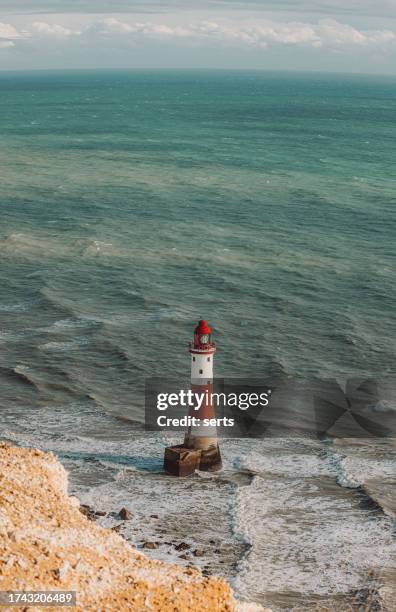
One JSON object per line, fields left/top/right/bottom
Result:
{"left": 0, "top": 17, "right": 396, "bottom": 50}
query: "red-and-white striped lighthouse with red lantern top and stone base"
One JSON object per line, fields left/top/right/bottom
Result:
{"left": 164, "top": 319, "right": 221, "bottom": 476}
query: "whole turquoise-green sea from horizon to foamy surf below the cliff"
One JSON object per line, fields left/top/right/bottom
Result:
{"left": 0, "top": 71, "right": 396, "bottom": 612}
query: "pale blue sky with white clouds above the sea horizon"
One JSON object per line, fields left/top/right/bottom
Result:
{"left": 0, "top": 0, "right": 396, "bottom": 75}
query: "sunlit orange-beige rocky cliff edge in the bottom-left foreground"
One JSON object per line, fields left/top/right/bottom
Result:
{"left": 0, "top": 443, "right": 262, "bottom": 612}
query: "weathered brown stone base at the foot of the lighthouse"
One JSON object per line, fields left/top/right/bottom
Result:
{"left": 164, "top": 444, "right": 222, "bottom": 476}
